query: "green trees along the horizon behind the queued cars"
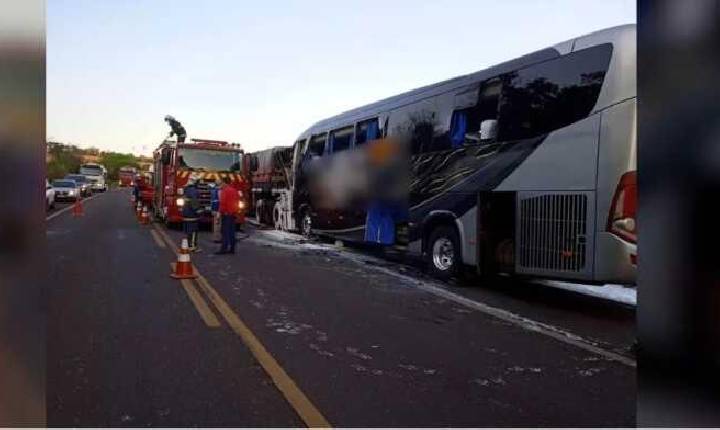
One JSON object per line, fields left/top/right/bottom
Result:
{"left": 47, "top": 142, "right": 140, "bottom": 180}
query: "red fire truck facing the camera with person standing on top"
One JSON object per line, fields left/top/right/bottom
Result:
{"left": 153, "top": 139, "right": 249, "bottom": 225}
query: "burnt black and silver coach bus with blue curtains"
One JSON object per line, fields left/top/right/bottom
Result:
{"left": 278, "top": 25, "right": 637, "bottom": 284}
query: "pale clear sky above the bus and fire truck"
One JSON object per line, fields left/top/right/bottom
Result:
{"left": 47, "top": 0, "right": 636, "bottom": 154}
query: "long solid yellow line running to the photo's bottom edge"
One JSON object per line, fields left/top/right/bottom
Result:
{"left": 197, "top": 273, "right": 330, "bottom": 427}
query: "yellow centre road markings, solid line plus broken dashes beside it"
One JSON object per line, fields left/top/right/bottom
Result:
{"left": 150, "top": 224, "right": 331, "bottom": 427}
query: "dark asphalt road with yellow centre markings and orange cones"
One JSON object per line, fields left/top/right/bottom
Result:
{"left": 47, "top": 189, "right": 636, "bottom": 427}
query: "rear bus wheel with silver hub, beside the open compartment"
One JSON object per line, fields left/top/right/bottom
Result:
{"left": 425, "top": 225, "right": 462, "bottom": 281}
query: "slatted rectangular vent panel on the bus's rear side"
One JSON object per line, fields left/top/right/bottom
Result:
{"left": 515, "top": 191, "right": 595, "bottom": 279}
